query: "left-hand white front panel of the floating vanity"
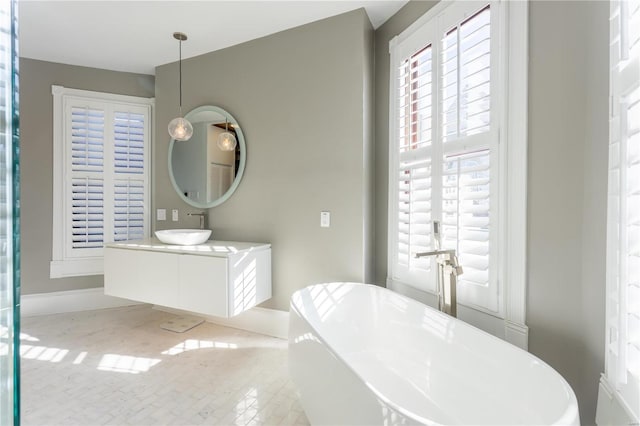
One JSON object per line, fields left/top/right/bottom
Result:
{"left": 104, "top": 247, "right": 178, "bottom": 306}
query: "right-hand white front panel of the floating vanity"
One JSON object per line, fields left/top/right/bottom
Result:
{"left": 178, "top": 255, "right": 229, "bottom": 318}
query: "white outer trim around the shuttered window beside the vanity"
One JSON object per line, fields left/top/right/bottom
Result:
{"left": 49, "top": 85, "right": 155, "bottom": 278}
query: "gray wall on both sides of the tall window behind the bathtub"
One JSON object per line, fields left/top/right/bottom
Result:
{"left": 375, "top": 1, "right": 608, "bottom": 424}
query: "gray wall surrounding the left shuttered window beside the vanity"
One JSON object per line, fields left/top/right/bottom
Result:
{"left": 20, "top": 58, "right": 154, "bottom": 294}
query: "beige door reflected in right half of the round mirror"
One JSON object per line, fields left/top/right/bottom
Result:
{"left": 206, "top": 124, "right": 236, "bottom": 202}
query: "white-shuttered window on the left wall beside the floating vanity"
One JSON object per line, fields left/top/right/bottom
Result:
{"left": 50, "top": 86, "right": 153, "bottom": 278}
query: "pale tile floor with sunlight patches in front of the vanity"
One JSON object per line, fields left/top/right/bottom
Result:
{"left": 21, "top": 305, "right": 309, "bottom": 426}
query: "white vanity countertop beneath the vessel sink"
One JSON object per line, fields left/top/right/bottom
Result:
{"left": 105, "top": 238, "right": 271, "bottom": 257}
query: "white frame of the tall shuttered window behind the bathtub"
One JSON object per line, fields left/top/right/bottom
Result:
{"left": 387, "top": 1, "right": 528, "bottom": 348}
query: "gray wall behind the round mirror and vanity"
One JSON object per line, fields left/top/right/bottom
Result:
{"left": 152, "top": 10, "right": 373, "bottom": 310}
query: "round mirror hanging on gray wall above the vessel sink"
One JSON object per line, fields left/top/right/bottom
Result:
{"left": 169, "top": 105, "right": 247, "bottom": 209}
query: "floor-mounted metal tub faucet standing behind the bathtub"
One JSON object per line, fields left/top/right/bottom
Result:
{"left": 414, "top": 221, "right": 462, "bottom": 318}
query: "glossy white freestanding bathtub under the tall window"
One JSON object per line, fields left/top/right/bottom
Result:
{"left": 289, "top": 283, "right": 580, "bottom": 425}
